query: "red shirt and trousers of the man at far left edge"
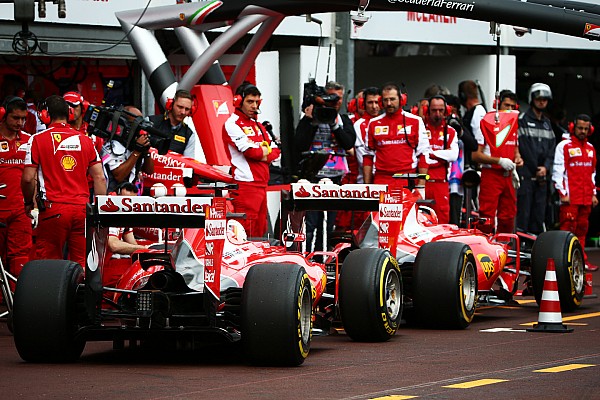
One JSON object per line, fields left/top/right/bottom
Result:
{"left": 0, "top": 132, "right": 31, "bottom": 275}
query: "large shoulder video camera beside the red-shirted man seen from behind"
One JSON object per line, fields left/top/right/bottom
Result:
{"left": 83, "top": 104, "right": 171, "bottom": 154}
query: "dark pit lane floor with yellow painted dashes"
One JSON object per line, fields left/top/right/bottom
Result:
{"left": 0, "top": 249, "right": 600, "bottom": 400}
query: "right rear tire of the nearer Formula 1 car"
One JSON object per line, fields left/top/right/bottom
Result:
{"left": 241, "top": 264, "right": 313, "bottom": 366}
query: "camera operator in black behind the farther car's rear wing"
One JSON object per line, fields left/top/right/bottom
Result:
{"left": 294, "top": 82, "right": 356, "bottom": 251}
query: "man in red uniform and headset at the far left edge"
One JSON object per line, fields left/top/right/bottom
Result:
{"left": 0, "top": 96, "right": 32, "bottom": 284}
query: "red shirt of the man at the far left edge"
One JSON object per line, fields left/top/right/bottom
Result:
{"left": 0, "top": 132, "right": 31, "bottom": 210}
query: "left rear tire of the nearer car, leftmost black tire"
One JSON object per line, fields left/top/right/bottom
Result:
{"left": 13, "top": 260, "right": 85, "bottom": 362}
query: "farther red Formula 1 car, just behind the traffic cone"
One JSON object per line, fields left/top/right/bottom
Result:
{"left": 287, "top": 175, "right": 584, "bottom": 328}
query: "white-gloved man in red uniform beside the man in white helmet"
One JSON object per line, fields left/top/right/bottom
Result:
{"left": 472, "top": 90, "right": 523, "bottom": 233}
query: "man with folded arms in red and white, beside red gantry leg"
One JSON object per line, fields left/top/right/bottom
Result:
{"left": 223, "top": 82, "right": 281, "bottom": 237}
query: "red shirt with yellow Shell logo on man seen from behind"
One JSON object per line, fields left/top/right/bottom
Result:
{"left": 25, "top": 123, "right": 100, "bottom": 205}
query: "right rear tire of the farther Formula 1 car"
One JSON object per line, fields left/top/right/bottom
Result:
{"left": 413, "top": 242, "right": 477, "bottom": 329}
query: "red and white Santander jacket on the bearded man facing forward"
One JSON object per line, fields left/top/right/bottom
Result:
{"left": 363, "top": 111, "right": 429, "bottom": 186}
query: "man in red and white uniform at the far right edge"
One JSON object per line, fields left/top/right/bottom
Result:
{"left": 552, "top": 114, "right": 598, "bottom": 271}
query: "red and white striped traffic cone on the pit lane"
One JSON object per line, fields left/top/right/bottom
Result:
{"left": 527, "top": 258, "right": 573, "bottom": 333}
